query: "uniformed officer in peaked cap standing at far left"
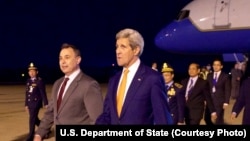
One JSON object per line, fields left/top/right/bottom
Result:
{"left": 25, "top": 63, "right": 48, "bottom": 141}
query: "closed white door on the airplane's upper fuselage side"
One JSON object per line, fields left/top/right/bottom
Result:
{"left": 214, "top": 0, "right": 230, "bottom": 29}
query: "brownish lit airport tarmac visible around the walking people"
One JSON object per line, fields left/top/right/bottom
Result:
{"left": 0, "top": 84, "right": 242, "bottom": 141}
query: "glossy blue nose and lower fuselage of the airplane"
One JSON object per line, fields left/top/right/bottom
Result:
{"left": 155, "top": 18, "right": 250, "bottom": 53}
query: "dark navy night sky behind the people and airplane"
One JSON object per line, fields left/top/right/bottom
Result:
{"left": 0, "top": 0, "right": 228, "bottom": 83}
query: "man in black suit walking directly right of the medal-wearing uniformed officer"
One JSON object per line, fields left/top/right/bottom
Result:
{"left": 180, "top": 63, "right": 216, "bottom": 125}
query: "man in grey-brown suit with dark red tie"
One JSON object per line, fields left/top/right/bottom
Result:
{"left": 34, "top": 43, "right": 103, "bottom": 141}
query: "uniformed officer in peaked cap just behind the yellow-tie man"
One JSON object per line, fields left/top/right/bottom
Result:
{"left": 161, "top": 63, "right": 184, "bottom": 125}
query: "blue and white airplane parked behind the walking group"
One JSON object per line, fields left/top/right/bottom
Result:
{"left": 155, "top": 0, "right": 250, "bottom": 61}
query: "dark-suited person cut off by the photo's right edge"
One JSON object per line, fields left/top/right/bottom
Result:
{"left": 231, "top": 67, "right": 250, "bottom": 125}
